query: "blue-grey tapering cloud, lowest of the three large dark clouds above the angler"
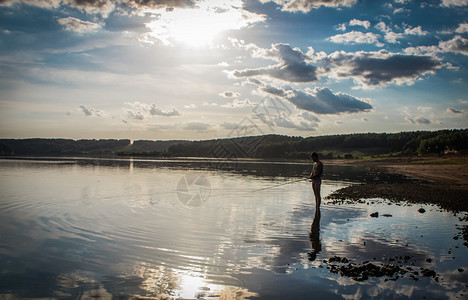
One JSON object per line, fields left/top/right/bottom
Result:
{"left": 263, "top": 87, "right": 372, "bottom": 116}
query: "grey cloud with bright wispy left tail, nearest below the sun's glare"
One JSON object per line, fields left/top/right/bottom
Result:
{"left": 233, "top": 44, "right": 317, "bottom": 82}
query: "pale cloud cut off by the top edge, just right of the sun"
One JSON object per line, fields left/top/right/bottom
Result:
{"left": 260, "top": 0, "right": 357, "bottom": 13}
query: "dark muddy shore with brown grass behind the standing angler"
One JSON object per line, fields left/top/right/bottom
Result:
{"left": 327, "top": 156, "right": 468, "bottom": 212}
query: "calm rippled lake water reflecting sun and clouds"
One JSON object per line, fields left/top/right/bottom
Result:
{"left": 0, "top": 158, "right": 468, "bottom": 299}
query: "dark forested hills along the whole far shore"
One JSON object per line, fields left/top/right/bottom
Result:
{"left": 0, "top": 129, "right": 468, "bottom": 159}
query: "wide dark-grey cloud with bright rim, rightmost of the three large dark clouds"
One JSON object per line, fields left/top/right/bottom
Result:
{"left": 324, "top": 50, "right": 442, "bottom": 87}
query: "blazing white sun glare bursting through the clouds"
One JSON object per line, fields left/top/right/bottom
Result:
{"left": 146, "top": 0, "right": 264, "bottom": 47}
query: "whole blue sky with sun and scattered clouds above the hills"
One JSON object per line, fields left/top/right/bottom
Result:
{"left": 0, "top": 0, "right": 468, "bottom": 140}
